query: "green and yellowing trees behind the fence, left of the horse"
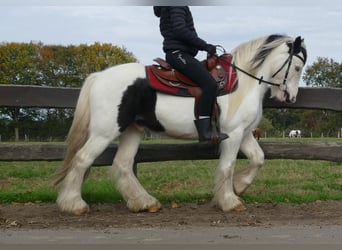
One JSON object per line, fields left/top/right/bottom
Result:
{"left": 0, "top": 42, "right": 136, "bottom": 140}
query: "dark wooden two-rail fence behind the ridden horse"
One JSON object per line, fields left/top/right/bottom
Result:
{"left": 0, "top": 85, "right": 342, "bottom": 165}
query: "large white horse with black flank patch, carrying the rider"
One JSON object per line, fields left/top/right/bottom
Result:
{"left": 55, "top": 35, "right": 307, "bottom": 214}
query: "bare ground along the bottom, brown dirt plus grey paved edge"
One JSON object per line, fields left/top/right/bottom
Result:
{"left": 0, "top": 201, "right": 342, "bottom": 244}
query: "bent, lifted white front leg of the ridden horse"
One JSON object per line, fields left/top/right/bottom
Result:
{"left": 234, "top": 133, "right": 264, "bottom": 195}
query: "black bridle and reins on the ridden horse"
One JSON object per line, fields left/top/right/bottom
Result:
{"left": 217, "top": 42, "right": 306, "bottom": 91}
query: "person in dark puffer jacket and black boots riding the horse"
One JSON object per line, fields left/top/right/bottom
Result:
{"left": 153, "top": 6, "right": 228, "bottom": 142}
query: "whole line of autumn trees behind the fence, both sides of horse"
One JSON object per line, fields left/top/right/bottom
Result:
{"left": 0, "top": 42, "right": 342, "bottom": 141}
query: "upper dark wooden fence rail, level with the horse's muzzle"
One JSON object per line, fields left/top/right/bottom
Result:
{"left": 0, "top": 85, "right": 342, "bottom": 111}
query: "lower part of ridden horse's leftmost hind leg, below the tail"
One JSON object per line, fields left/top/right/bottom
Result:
{"left": 57, "top": 136, "right": 111, "bottom": 215}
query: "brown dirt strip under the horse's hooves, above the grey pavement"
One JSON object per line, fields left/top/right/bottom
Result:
{"left": 0, "top": 201, "right": 342, "bottom": 230}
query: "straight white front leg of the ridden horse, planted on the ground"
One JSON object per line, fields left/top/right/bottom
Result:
{"left": 214, "top": 133, "right": 246, "bottom": 212}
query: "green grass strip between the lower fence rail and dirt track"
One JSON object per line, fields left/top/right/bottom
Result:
{"left": 0, "top": 160, "right": 342, "bottom": 203}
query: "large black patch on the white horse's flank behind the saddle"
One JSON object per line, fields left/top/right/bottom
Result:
{"left": 117, "top": 78, "right": 165, "bottom": 132}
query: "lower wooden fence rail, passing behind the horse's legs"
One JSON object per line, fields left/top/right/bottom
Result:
{"left": 0, "top": 142, "right": 342, "bottom": 163}
